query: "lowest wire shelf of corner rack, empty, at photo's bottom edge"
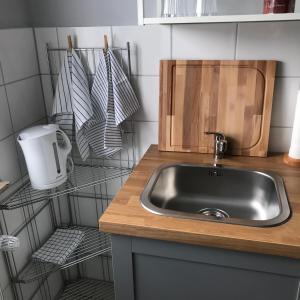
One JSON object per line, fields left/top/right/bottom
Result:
{"left": 57, "top": 279, "right": 115, "bottom": 300}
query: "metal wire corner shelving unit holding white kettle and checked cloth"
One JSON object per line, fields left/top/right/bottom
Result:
{"left": 0, "top": 43, "right": 136, "bottom": 300}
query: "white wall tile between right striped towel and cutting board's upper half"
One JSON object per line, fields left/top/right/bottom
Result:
{"left": 132, "top": 76, "right": 159, "bottom": 122}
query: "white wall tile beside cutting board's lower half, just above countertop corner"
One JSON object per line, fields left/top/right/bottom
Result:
{"left": 135, "top": 122, "right": 158, "bottom": 160}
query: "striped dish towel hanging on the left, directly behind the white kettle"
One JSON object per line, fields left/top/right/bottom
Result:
{"left": 52, "top": 50, "right": 93, "bottom": 160}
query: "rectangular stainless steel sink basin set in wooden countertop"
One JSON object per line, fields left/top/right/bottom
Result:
{"left": 141, "top": 164, "right": 290, "bottom": 227}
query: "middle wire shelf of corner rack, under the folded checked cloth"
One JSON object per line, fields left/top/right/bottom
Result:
{"left": 14, "top": 226, "right": 111, "bottom": 283}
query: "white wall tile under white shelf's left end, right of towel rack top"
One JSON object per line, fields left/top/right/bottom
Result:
{"left": 112, "top": 25, "right": 171, "bottom": 75}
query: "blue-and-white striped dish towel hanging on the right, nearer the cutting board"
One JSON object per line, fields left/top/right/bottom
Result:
{"left": 86, "top": 50, "right": 139, "bottom": 156}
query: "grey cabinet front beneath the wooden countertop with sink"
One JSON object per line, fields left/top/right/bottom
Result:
{"left": 112, "top": 235, "right": 300, "bottom": 300}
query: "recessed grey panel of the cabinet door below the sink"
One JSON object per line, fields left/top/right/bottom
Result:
{"left": 133, "top": 254, "right": 299, "bottom": 300}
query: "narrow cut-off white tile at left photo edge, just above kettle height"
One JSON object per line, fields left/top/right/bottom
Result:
{"left": 0, "top": 86, "right": 13, "bottom": 140}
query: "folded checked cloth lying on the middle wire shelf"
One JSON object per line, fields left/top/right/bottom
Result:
{"left": 32, "top": 229, "right": 84, "bottom": 265}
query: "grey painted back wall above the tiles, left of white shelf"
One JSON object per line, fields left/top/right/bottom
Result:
{"left": 28, "top": 0, "right": 137, "bottom": 27}
